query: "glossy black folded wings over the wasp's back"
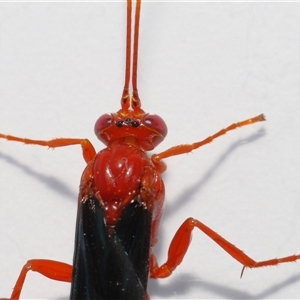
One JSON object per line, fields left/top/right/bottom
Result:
{"left": 70, "top": 197, "right": 151, "bottom": 300}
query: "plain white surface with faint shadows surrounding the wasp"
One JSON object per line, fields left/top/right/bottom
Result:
{"left": 0, "top": 1, "right": 300, "bottom": 299}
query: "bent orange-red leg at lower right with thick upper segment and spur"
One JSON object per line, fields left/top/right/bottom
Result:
{"left": 150, "top": 218, "right": 300, "bottom": 278}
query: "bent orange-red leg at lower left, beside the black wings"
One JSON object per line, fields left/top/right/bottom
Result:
{"left": 6, "top": 259, "right": 73, "bottom": 300}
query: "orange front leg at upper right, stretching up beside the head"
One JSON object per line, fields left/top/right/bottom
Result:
{"left": 151, "top": 114, "right": 266, "bottom": 172}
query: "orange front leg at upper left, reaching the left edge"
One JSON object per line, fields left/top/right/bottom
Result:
{"left": 0, "top": 133, "right": 96, "bottom": 163}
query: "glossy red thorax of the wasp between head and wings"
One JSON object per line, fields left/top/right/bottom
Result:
{"left": 79, "top": 140, "right": 164, "bottom": 235}
